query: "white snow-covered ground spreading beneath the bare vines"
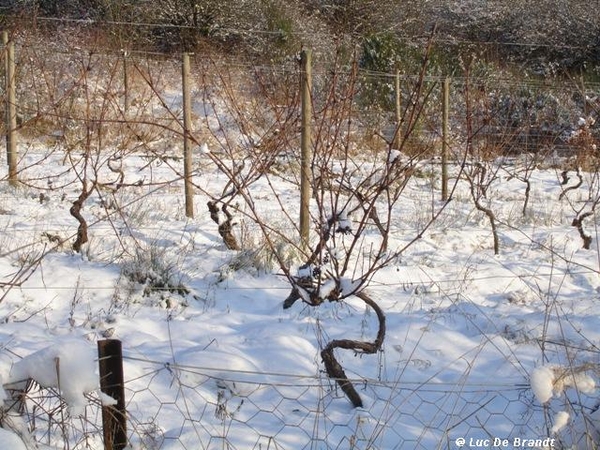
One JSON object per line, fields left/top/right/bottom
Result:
{"left": 0, "top": 142, "right": 600, "bottom": 449}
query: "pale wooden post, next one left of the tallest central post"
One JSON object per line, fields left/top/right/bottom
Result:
{"left": 181, "top": 53, "right": 194, "bottom": 219}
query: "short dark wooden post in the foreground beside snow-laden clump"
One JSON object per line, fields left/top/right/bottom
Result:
{"left": 98, "top": 339, "right": 127, "bottom": 450}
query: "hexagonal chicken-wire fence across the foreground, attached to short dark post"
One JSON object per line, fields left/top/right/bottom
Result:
{"left": 2, "top": 340, "right": 599, "bottom": 450}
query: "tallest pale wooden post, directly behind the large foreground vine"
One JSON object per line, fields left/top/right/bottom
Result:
{"left": 300, "top": 49, "right": 312, "bottom": 249}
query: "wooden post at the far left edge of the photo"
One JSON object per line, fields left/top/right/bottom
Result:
{"left": 2, "top": 31, "right": 17, "bottom": 186}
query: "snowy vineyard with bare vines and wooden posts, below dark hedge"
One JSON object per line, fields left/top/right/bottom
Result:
{"left": 0, "top": 30, "right": 600, "bottom": 450}
